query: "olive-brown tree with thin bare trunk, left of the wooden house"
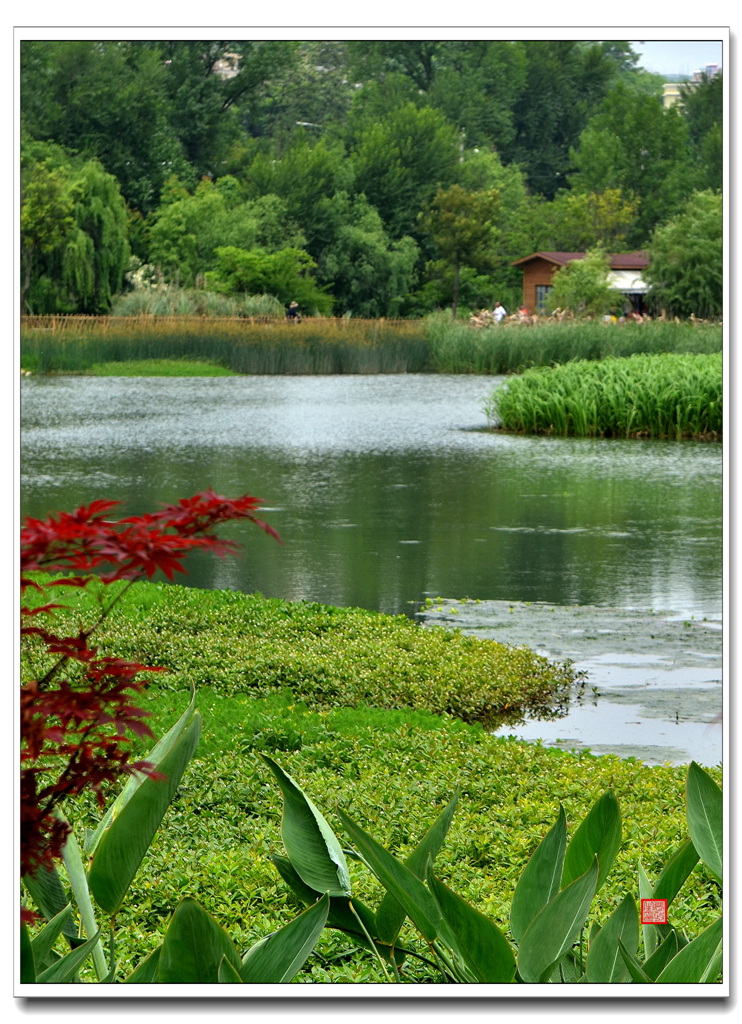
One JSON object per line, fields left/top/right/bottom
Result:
{"left": 421, "top": 185, "right": 499, "bottom": 318}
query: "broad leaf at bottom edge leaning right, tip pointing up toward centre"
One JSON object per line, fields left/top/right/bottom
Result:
{"left": 238, "top": 893, "right": 330, "bottom": 985}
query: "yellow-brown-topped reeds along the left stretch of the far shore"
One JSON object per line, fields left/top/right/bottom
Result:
{"left": 21, "top": 316, "right": 429, "bottom": 375}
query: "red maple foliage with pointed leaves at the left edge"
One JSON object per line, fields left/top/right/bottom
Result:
{"left": 20, "top": 490, "right": 279, "bottom": 874}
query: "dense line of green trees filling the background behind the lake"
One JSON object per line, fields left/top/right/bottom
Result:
{"left": 20, "top": 40, "right": 723, "bottom": 316}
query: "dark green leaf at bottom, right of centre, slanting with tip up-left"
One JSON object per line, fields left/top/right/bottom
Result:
{"left": 428, "top": 871, "right": 515, "bottom": 984}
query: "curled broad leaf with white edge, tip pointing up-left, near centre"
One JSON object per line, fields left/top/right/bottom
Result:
{"left": 261, "top": 754, "right": 350, "bottom": 896}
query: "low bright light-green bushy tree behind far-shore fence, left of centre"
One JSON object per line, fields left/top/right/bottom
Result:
{"left": 201, "top": 246, "right": 333, "bottom": 315}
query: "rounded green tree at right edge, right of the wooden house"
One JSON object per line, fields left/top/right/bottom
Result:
{"left": 646, "top": 190, "right": 724, "bottom": 318}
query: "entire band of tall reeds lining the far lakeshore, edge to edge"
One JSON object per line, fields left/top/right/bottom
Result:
{"left": 20, "top": 315, "right": 722, "bottom": 374}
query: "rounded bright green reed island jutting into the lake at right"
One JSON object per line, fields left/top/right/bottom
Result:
{"left": 485, "top": 353, "right": 723, "bottom": 440}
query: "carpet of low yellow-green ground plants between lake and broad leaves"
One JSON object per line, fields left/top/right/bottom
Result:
{"left": 21, "top": 584, "right": 719, "bottom": 983}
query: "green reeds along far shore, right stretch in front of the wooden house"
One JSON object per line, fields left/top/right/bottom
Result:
{"left": 425, "top": 316, "right": 723, "bottom": 374}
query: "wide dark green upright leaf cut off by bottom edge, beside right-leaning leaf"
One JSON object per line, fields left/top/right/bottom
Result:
{"left": 158, "top": 896, "right": 239, "bottom": 985}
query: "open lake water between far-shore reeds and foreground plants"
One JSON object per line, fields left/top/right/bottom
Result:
{"left": 20, "top": 375, "right": 723, "bottom": 760}
